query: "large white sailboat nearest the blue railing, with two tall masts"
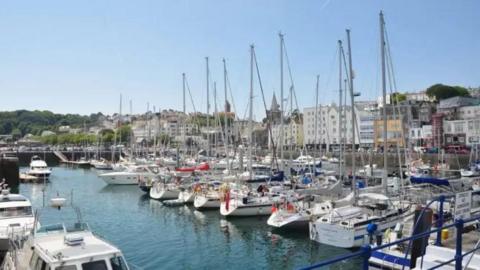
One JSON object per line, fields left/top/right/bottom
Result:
{"left": 310, "top": 13, "right": 410, "bottom": 248}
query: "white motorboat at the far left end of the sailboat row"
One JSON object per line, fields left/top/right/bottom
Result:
{"left": 99, "top": 165, "right": 159, "bottom": 185}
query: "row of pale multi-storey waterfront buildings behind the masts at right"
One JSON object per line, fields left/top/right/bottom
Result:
{"left": 269, "top": 92, "right": 480, "bottom": 149}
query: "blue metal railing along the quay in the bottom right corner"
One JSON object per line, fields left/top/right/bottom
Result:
{"left": 300, "top": 191, "right": 480, "bottom": 270}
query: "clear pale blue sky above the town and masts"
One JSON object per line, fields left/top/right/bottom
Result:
{"left": 0, "top": 0, "right": 480, "bottom": 116}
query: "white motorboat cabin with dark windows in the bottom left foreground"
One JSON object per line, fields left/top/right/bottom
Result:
{"left": 1, "top": 223, "right": 129, "bottom": 270}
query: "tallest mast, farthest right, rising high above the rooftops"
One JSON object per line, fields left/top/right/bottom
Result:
{"left": 380, "top": 11, "right": 388, "bottom": 194}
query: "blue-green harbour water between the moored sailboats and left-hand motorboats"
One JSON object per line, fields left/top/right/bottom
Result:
{"left": 20, "top": 167, "right": 359, "bottom": 270}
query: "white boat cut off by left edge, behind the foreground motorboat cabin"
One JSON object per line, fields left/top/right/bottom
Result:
{"left": 0, "top": 189, "right": 35, "bottom": 252}
